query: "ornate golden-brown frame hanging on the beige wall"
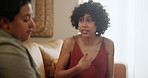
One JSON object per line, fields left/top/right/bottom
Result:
{"left": 31, "top": 0, "right": 53, "bottom": 37}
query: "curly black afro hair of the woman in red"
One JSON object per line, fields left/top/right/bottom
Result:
{"left": 71, "top": 2, "right": 110, "bottom": 36}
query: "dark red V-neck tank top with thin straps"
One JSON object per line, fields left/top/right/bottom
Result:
{"left": 68, "top": 36, "right": 107, "bottom": 78}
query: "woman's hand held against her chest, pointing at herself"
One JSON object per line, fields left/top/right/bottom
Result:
{"left": 77, "top": 53, "right": 92, "bottom": 70}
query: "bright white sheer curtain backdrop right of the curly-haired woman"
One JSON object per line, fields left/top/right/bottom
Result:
{"left": 100, "top": 0, "right": 148, "bottom": 78}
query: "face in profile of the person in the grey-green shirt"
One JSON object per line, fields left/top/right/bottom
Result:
{"left": 8, "top": 4, "right": 35, "bottom": 42}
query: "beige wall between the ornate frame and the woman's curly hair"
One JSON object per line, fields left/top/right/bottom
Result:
{"left": 28, "top": 0, "right": 78, "bottom": 42}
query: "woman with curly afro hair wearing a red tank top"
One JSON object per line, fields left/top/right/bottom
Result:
{"left": 55, "top": 0, "right": 114, "bottom": 78}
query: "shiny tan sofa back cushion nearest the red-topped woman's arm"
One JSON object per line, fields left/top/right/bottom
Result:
{"left": 39, "top": 39, "right": 63, "bottom": 78}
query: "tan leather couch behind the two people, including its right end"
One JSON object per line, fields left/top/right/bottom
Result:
{"left": 23, "top": 39, "right": 126, "bottom": 78}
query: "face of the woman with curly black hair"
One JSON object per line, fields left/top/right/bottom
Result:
{"left": 78, "top": 14, "right": 97, "bottom": 37}
